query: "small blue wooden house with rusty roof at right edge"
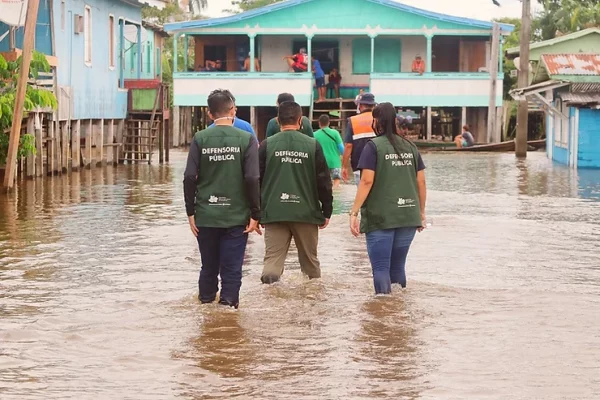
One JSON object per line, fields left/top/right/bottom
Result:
{"left": 512, "top": 53, "right": 600, "bottom": 169}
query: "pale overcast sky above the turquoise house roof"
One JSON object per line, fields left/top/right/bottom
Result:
{"left": 207, "top": 0, "right": 536, "bottom": 21}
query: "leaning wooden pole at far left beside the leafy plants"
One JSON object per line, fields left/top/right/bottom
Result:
{"left": 4, "top": 0, "right": 40, "bottom": 189}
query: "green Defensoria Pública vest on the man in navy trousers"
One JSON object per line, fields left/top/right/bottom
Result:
{"left": 194, "top": 126, "right": 252, "bottom": 228}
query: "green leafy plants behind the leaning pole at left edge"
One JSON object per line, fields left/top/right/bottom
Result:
{"left": 0, "top": 51, "right": 58, "bottom": 165}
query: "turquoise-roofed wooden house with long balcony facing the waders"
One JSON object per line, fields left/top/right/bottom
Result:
{"left": 165, "top": 0, "right": 513, "bottom": 142}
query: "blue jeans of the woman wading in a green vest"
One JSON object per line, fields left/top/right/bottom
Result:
{"left": 367, "top": 228, "right": 417, "bottom": 294}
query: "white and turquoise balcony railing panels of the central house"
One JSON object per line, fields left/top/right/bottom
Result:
{"left": 173, "top": 72, "right": 503, "bottom": 107}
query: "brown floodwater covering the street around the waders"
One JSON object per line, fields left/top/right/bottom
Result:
{"left": 0, "top": 152, "right": 600, "bottom": 400}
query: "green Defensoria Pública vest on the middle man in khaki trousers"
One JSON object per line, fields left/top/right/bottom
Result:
{"left": 260, "top": 131, "right": 325, "bottom": 225}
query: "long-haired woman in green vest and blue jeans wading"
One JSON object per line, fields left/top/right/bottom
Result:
{"left": 350, "top": 103, "right": 427, "bottom": 294}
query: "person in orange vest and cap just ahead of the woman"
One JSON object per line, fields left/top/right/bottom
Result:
{"left": 342, "top": 93, "right": 377, "bottom": 185}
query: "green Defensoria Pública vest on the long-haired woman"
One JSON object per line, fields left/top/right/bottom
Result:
{"left": 360, "top": 136, "right": 422, "bottom": 233}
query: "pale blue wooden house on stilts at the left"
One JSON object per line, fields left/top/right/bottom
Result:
{"left": 0, "top": 0, "right": 165, "bottom": 170}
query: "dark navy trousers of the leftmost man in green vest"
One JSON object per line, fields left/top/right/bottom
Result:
{"left": 198, "top": 226, "right": 248, "bottom": 307}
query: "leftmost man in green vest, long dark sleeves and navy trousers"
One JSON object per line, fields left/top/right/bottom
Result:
{"left": 183, "top": 90, "right": 262, "bottom": 308}
